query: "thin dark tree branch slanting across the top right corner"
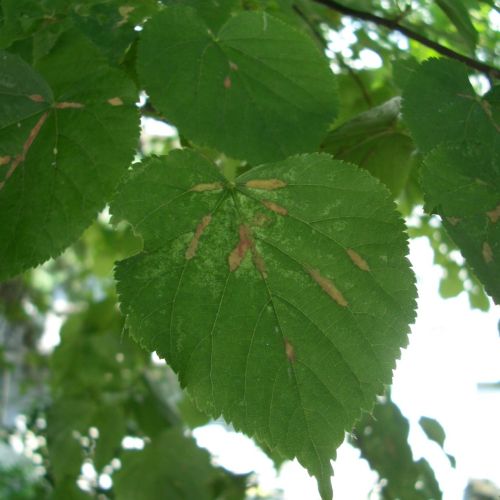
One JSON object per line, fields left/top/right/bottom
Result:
{"left": 313, "top": 0, "right": 500, "bottom": 78}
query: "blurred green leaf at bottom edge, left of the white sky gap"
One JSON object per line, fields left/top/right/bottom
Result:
{"left": 113, "top": 427, "right": 237, "bottom": 500}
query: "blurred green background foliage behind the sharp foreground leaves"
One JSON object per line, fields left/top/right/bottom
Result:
{"left": 0, "top": 0, "right": 500, "bottom": 500}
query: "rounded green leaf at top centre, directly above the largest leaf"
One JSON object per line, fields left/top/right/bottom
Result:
{"left": 138, "top": 6, "right": 337, "bottom": 163}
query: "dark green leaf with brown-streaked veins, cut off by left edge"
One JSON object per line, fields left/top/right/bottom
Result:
{"left": 0, "top": 33, "right": 138, "bottom": 279}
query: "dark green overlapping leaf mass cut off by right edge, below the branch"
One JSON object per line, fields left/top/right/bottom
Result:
{"left": 404, "top": 60, "right": 500, "bottom": 303}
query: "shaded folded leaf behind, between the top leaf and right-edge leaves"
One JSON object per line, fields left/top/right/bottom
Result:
{"left": 322, "top": 97, "right": 414, "bottom": 197}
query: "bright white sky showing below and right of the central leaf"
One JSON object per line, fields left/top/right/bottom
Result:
{"left": 194, "top": 238, "right": 500, "bottom": 500}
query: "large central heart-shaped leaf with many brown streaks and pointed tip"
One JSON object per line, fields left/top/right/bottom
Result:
{"left": 112, "top": 151, "right": 415, "bottom": 498}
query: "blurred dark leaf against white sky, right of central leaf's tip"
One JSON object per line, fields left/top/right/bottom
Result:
{"left": 352, "top": 400, "right": 442, "bottom": 500}
